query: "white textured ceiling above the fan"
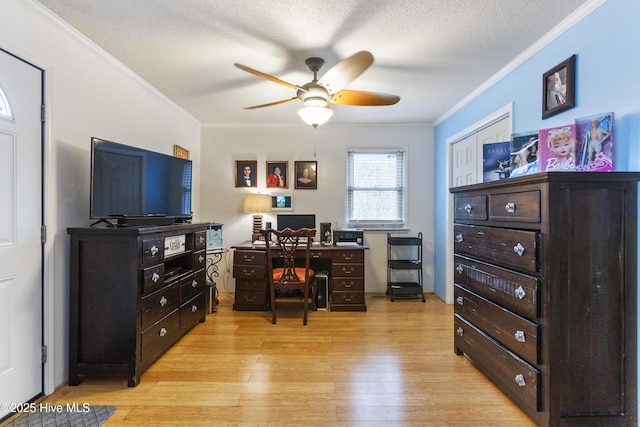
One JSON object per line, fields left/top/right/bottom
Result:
{"left": 38, "top": 0, "right": 588, "bottom": 126}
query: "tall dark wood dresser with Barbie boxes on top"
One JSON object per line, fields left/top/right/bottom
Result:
{"left": 451, "top": 172, "right": 640, "bottom": 426}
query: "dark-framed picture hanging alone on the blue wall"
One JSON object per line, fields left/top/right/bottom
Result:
{"left": 542, "top": 55, "right": 576, "bottom": 119}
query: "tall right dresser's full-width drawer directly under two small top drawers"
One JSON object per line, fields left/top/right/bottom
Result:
{"left": 453, "top": 224, "right": 539, "bottom": 273}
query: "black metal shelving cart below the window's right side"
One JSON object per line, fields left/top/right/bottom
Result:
{"left": 387, "top": 232, "right": 425, "bottom": 302}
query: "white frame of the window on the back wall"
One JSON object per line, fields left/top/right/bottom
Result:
{"left": 345, "top": 147, "right": 408, "bottom": 230}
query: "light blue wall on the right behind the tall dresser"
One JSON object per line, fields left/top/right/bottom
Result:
{"left": 434, "top": 0, "right": 640, "bottom": 298}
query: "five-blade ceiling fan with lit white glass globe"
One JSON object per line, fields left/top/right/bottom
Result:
{"left": 233, "top": 51, "right": 400, "bottom": 128}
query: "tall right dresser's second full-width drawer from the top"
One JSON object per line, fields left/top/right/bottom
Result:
{"left": 454, "top": 255, "right": 540, "bottom": 320}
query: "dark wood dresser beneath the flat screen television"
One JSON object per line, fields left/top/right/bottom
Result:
{"left": 68, "top": 224, "right": 207, "bottom": 387}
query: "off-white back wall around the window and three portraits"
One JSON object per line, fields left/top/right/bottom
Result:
{"left": 201, "top": 124, "right": 434, "bottom": 292}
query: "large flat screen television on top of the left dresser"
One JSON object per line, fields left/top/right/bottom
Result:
{"left": 89, "top": 137, "right": 192, "bottom": 225}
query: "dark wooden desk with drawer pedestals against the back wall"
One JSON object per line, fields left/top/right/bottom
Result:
{"left": 231, "top": 242, "right": 369, "bottom": 311}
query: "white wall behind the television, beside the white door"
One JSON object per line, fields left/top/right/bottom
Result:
{"left": 0, "top": 0, "right": 200, "bottom": 392}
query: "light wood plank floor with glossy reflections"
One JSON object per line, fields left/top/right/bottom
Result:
{"left": 35, "top": 294, "right": 534, "bottom": 427}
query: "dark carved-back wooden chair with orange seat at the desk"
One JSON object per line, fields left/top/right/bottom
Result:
{"left": 260, "top": 228, "right": 318, "bottom": 325}
